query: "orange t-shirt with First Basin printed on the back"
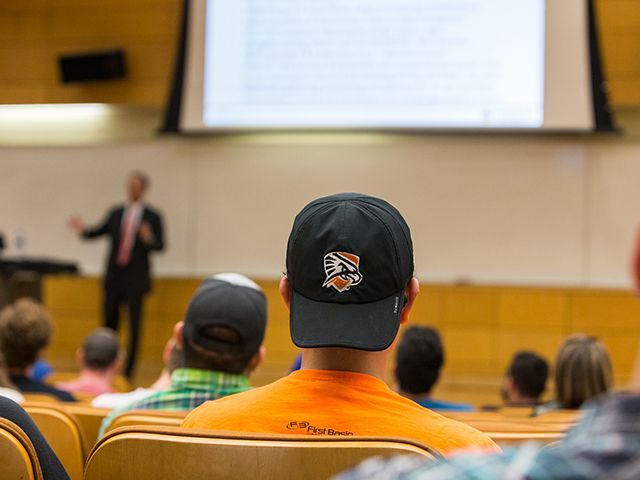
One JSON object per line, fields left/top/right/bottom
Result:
{"left": 182, "top": 370, "right": 499, "bottom": 455}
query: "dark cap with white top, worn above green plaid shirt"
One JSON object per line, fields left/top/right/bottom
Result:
{"left": 184, "top": 273, "right": 267, "bottom": 357}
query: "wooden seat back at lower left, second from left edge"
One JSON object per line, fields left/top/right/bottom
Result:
{"left": 23, "top": 403, "right": 85, "bottom": 480}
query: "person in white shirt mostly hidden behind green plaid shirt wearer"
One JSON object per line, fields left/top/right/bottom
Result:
{"left": 91, "top": 337, "right": 182, "bottom": 408}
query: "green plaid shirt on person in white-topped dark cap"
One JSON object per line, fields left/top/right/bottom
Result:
{"left": 98, "top": 368, "right": 251, "bottom": 438}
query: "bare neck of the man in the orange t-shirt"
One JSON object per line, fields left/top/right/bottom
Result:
{"left": 302, "top": 348, "right": 387, "bottom": 381}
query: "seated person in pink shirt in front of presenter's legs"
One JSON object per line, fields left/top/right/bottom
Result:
{"left": 55, "top": 328, "right": 122, "bottom": 397}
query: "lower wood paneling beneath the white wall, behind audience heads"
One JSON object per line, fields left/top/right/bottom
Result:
{"left": 44, "top": 277, "right": 640, "bottom": 404}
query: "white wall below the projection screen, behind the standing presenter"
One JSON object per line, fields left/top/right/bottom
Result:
{"left": 0, "top": 135, "right": 640, "bottom": 286}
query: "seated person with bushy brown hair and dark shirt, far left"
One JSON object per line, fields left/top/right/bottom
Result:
{"left": 0, "top": 298, "right": 75, "bottom": 402}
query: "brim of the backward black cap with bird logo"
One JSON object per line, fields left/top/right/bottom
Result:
{"left": 290, "top": 289, "right": 404, "bottom": 351}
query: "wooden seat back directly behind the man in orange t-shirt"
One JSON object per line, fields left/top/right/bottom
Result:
{"left": 85, "top": 426, "right": 439, "bottom": 480}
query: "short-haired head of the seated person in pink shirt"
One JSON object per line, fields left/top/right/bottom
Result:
{"left": 78, "top": 328, "right": 122, "bottom": 373}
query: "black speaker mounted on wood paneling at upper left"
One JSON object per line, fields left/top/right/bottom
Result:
{"left": 58, "top": 48, "right": 127, "bottom": 83}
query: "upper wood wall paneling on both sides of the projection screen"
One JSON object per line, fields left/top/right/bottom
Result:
{"left": 0, "top": 0, "right": 640, "bottom": 106}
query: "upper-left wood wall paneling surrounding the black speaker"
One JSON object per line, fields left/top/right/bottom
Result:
{"left": 0, "top": 0, "right": 182, "bottom": 106}
